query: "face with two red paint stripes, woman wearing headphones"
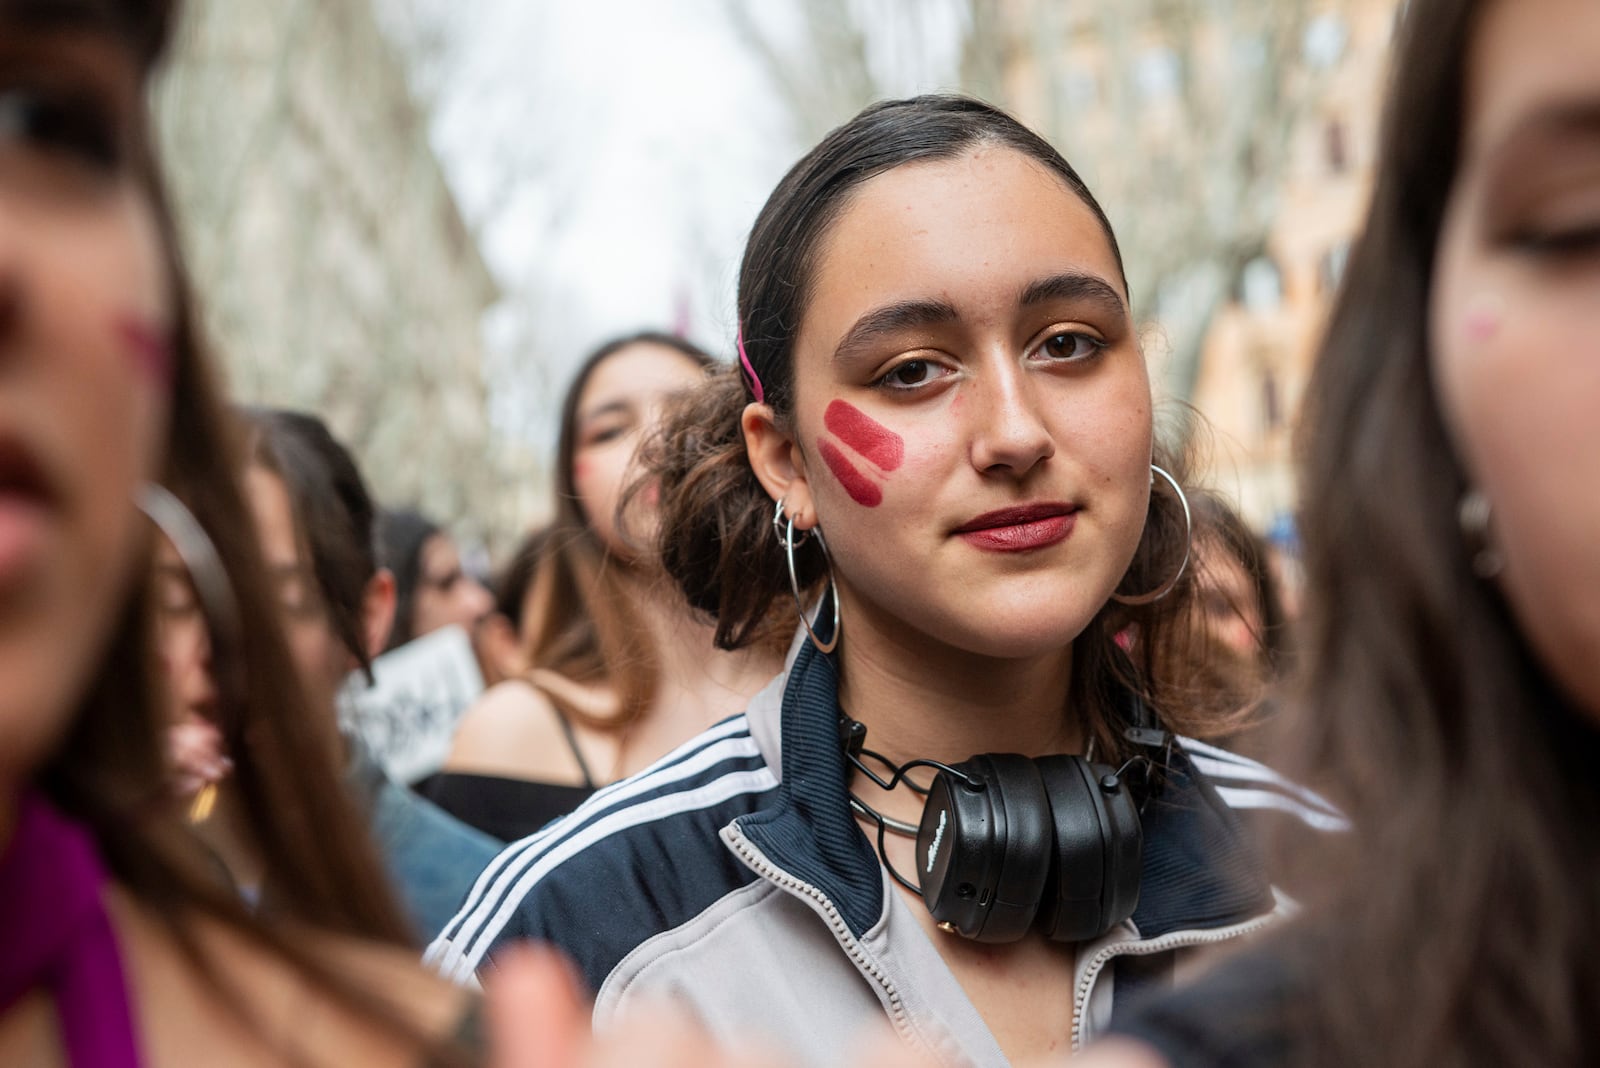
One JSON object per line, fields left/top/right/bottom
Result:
{"left": 786, "top": 147, "right": 1150, "bottom": 657}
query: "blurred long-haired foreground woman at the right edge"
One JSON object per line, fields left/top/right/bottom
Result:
{"left": 1085, "top": 0, "right": 1600, "bottom": 1068}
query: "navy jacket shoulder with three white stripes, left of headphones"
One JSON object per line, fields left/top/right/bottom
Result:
{"left": 427, "top": 716, "right": 778, "bottom": 990}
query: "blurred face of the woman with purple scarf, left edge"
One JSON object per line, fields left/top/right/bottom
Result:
{"left": 0, "top": 27, "right": 173, "bottom": 783}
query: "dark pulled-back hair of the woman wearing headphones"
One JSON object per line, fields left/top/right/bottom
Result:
{"left": 646, "top": 96, "right": 1230, "bottom": 763}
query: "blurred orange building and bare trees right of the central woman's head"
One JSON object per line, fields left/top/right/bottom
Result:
{"left": 989, "top": 0, "right": 1402, "bottom": 532}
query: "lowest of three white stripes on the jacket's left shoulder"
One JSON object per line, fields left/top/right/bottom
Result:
{"left": 426, "top": 767, "right": 778, "bottom": 983}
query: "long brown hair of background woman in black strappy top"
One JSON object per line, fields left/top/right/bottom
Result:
{"left": 522, "top": 331, "right": 714, "bottom": 731}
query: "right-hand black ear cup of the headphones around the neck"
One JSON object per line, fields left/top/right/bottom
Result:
{"left": 1038, "top": 756, "right": 1144, "bottom": 942}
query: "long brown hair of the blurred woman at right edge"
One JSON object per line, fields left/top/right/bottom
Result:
{"left": 1294, "top": 0, "right": 1600, "bottom": 1065}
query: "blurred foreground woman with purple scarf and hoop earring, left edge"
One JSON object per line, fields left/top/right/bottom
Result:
{"left": 0, "top": 0, "right": 470, "bottom": 1068}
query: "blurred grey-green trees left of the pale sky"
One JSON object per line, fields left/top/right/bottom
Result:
{"left": 155, "top": 0, "right": 536, "bottom": 542}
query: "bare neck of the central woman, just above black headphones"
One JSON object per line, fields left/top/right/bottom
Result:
{"left": 840, "top": 591, "right": 1083, "bottom": 777}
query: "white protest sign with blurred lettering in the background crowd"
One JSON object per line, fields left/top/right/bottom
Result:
{"left": 339, "top": 627, "right": 483, "bottom": 783}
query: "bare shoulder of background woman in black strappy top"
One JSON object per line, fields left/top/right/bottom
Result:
{"left": 445, "top": 679, "right": 573, "bottom": 780}
